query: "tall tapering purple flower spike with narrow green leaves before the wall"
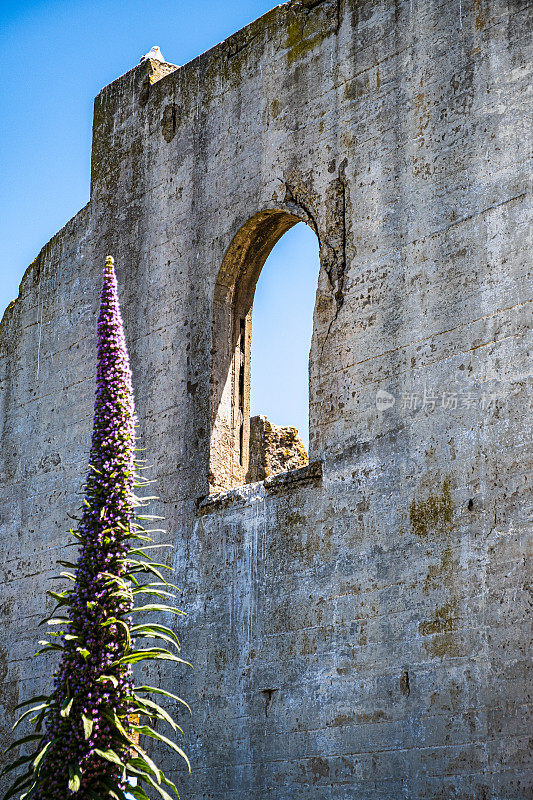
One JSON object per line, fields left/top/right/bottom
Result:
{"left": 4, "top": 256, "right": 189, "bottom": 800}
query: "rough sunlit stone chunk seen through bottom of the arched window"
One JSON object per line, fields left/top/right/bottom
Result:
{"left": 246, "top": 414, "right": 309, "bottom": 483}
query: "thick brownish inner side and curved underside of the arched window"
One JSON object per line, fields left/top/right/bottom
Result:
{"left": 209, "top": 210, "right": 318, "bottom": 492}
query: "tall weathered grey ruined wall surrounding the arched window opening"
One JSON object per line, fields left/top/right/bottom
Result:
{"left": 0, "top": 0, "right": 531, "bottom": 800}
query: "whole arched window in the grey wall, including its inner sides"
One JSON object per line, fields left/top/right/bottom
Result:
{"left": 209, "top": 211, "right": 318, "bottom": 492}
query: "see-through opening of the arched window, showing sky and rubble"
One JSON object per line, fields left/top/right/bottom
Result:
{"left": 246, "top": 222, "right": 320, "bottom": 483}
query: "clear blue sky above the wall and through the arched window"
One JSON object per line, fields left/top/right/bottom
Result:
{"left": 0, "top": 0, "right": 317, "bottom": 450}
